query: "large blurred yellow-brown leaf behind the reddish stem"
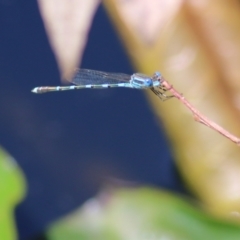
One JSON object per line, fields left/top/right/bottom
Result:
{"left": 105, "top": 0, "right": 240, "bottom": 220}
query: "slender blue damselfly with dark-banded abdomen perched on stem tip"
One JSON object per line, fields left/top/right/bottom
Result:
{"left": 32, "top": 69, "right": 172, "bottom": 100}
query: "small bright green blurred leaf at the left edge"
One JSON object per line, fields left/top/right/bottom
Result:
{"left": 0, "top": 148, "right": 26, "bottom": 240}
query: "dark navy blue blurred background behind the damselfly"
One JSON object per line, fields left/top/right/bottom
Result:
{"left": 0, "top": 0, "right": 182, "bottom": 239}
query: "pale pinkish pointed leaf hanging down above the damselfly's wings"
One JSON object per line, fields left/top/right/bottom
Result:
{"left": 38, "top": 0, "right": 100, "bottom": 79}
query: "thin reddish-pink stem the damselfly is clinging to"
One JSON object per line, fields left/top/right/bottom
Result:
{"left": 161, "top": 79, "right": 240, "bottom": 146}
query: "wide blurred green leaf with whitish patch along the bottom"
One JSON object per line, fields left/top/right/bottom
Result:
{"left": 47, "top": 188, "right": 240, "bottom": 240}
